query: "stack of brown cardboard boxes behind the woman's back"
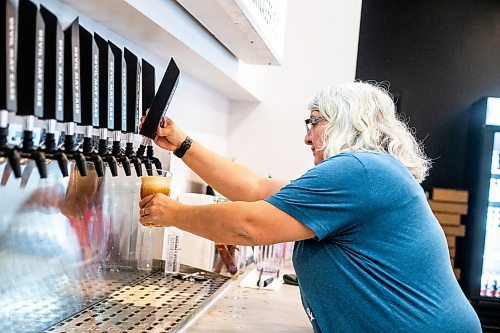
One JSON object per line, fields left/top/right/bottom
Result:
{"left": 429, "top": 188, "right": 469, "bottom": 279}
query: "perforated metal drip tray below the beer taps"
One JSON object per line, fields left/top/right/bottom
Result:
{"left": 44, "top": 266, "right": 229, "bottom": 333}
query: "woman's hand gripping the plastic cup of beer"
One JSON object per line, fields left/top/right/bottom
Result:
{"left": 139, "top": 193, "right": 182, "bottom": 227}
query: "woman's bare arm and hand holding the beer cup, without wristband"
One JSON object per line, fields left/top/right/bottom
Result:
{"left": 139, "top": 193, "right": 315, "bottom": 245}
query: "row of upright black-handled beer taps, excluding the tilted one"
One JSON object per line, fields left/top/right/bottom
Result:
{"left": 0, "top": 0, "right": 162, "bottom": 185}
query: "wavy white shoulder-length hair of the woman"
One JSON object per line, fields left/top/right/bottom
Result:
{"left": 308, "top": 81, "right": 431, "bottom": 182}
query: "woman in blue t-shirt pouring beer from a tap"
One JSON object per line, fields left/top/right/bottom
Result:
{"left": 140, "top": 82, "right": 481, "bottom": 332}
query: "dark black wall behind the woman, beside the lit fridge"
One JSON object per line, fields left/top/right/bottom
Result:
{"left": 356, "top": 0, "right": 500, "bottom": 190}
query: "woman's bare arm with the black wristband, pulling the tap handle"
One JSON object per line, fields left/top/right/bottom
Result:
{"left": 155, "top": 117, "right": 289, "bottom": 201}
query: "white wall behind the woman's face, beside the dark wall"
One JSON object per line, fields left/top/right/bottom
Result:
{"left": 228, "top": 0, "right": 361, "bottom": 179}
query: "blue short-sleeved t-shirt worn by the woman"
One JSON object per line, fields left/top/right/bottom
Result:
{"left": 266, "top": 152, "right": 481, "bottom": 333}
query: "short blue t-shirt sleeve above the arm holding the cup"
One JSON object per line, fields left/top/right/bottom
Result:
{"left": 265, "top": 154, "right": 370, "bottom": 240}
